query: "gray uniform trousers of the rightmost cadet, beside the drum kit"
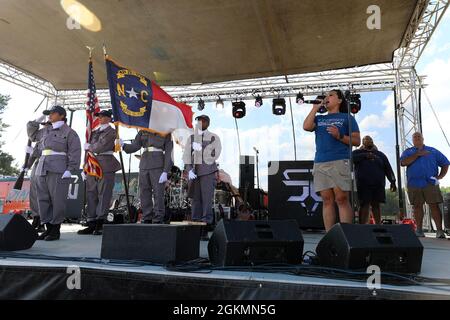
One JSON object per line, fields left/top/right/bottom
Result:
{"left": 192, "top": 172, "right": 217, "bottom": 224}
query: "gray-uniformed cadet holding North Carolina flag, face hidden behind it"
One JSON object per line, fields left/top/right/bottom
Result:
{"left": 119, "top": 130, "right": 173, "bottom": 224}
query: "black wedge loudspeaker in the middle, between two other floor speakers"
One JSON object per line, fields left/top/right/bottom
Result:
{"left": 208, "top": 220, "right": 303, "bottom": 266}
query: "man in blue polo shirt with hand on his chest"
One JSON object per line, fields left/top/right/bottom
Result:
{"left": 400, "top": 132, "right": 450, "bottom": 239}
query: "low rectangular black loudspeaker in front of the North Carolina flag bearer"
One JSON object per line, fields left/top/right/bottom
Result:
{"left": 101, "top": 224, "right": 201, "bottom": 264}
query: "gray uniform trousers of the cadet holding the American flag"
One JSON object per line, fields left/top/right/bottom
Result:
{"left": 86, "top": 172, "right": 116, "bottom": 222}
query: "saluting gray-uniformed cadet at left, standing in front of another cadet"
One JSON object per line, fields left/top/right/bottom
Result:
{"left": 27, "top": 106, "right": 81, "bottom": 241}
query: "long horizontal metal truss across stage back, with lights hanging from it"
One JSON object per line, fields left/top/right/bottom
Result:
{"left": 54, "top": 64, "right": 424, "bottom": 110}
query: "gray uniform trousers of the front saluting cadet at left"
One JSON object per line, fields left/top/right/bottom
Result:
{"left": 37, "top": 172, "right": 73, "bottom": 224}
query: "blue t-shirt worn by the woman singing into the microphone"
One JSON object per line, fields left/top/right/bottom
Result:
{"left": 314, "top": 113, "right": 359, "bottom": 163}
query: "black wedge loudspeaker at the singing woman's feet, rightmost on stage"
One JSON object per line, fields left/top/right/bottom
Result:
{"left": 316, "top": 223, "right": 423, "bottom": 273}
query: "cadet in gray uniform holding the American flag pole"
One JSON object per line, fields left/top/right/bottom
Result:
{"left": 78, "top": 110, "right": 121, "bottom": 235}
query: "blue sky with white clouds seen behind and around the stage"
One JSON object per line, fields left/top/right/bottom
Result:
{"left": 0, "top": 10, "right": 450, "bottom": 190}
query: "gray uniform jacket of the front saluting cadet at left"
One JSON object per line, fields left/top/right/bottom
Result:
{"left": 27, "top": 121, "right": 81, "bottom": 176}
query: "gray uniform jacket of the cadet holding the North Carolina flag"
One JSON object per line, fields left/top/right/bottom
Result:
{"left": 123, "top": 130, "right": 173, "bottom": 172}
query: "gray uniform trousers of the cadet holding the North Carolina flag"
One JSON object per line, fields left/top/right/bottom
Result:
{"left": 139, "top": 168, "right": 165, "bottom": 223}
